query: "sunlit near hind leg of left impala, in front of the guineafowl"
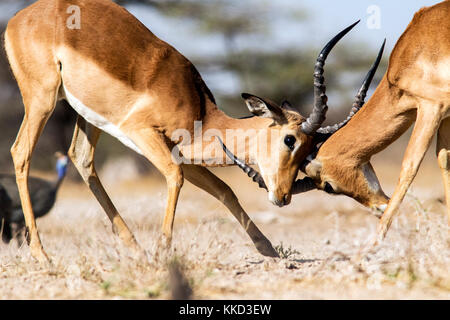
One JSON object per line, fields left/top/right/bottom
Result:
{"left": 11, "top": 87, "right": 59, "bottom": 262}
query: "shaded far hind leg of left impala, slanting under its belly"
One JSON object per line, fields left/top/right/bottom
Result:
{"left": 69, "top": 116, "right": 140, "bottom": 252}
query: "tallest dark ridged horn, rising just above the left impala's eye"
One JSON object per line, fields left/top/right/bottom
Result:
{"left": 302, "top": 20, "right": 361, "bottom": 136}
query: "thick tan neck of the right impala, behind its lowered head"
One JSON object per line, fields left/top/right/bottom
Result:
{"left": 317, "top": 75, "right": 416, "bottom": 166}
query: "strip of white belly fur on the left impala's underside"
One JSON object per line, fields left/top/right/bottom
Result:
{"left": 62, "top": 85, "right": 142, "bottom": 154}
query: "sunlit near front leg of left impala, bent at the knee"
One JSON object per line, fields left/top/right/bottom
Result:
{"left": 129, "top": 129, "right": 184, "bottom": 245}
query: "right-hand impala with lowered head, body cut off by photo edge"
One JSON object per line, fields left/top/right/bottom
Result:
{"left": 231, "top": 0, "right": 450, "bottom": 247}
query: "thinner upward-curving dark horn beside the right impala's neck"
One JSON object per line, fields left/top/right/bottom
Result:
{"left": 317, "top": 39, "right": 386, "bottom": 135}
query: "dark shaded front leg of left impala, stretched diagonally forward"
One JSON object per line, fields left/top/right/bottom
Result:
{"left": 183, "top": 165, "right": 278, "bottom": 257}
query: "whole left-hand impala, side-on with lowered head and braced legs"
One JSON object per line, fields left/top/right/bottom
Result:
{"left": 4, "top": 0, "right": 358, "bottom": 260}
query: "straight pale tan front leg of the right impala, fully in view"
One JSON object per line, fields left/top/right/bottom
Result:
{"left": 373, "top": 103, "right": 442, "bottom": 246}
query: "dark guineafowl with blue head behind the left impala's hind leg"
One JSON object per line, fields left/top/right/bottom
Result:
{"left": 0, "top": 152, "right": 69, "bottom": 243}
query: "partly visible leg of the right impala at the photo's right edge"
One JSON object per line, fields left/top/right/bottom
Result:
{"left": 436, "top": 118, "right": 450, "bottom": 225}
